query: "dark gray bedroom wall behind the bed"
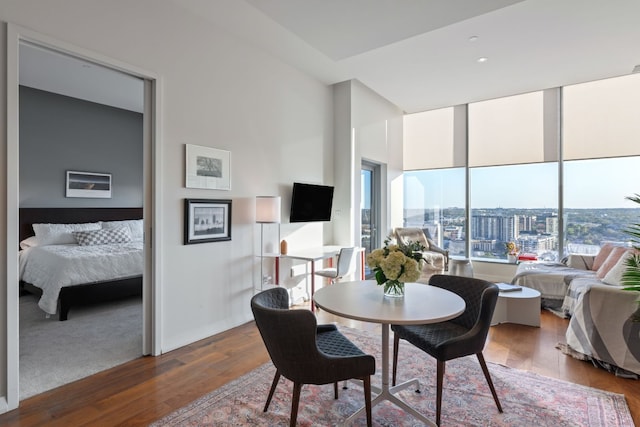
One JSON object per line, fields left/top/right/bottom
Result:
{"left": 19, "top": 86, "right": 144, "bottom": 208}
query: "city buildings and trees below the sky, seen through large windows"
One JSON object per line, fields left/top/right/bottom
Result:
{"left": 404, "top": 208, "right": 640, "bottom": 261}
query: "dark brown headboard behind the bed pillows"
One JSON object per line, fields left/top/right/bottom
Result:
{"left": 18, "top": 208, "right": 142, "bottom": 242}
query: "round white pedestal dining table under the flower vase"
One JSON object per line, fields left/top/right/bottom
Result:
{"left": 313, "top": 280, "right": 465, "bottom": 426}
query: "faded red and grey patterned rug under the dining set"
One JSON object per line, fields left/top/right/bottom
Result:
{"left": 152, "top": 327, "right": 634, "bottom": 427}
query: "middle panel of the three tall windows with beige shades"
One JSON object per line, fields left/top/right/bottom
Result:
{"left": 468, "top": 90, "right": 559, "bottom": 260}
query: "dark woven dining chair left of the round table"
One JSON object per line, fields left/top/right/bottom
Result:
{"left": 251, "top": 287, "right": 376, "bottom": 427}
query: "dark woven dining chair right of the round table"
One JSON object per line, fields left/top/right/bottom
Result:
{"left": 391, "top": 274, "right": 502, "bottom": 426}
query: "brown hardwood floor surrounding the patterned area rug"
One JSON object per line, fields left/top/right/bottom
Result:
{"left": 0, "top": 311, "right": 640, "bottom": 427}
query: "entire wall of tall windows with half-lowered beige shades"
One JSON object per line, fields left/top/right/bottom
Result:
{"left": 404, "top": 75, "right": 640, "bottom": 261}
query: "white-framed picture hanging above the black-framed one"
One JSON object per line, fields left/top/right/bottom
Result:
{"left": 185, "top": 144, "right": 231, "bottom": 190}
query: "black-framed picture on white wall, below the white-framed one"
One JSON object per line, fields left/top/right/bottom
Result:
{"left": 184, "top": 199, "right": 231, "bottom": 245}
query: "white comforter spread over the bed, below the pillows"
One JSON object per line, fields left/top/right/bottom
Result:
{"left": 20, "top": 241, "right": 144, "bottom": 314}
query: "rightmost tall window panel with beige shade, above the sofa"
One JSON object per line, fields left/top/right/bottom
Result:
{"left": 562, "top": 74, "right": 640, "bottom": 253}
